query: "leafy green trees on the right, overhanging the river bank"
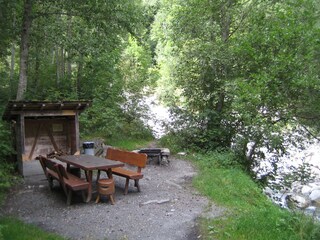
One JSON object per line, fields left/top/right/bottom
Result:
{"left": 153, "top": 0, "right": 320, "bottom": 170}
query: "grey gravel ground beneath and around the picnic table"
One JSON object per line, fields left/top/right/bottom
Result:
{"left": 0, "top": 158, "right": 223, "bottom": 240}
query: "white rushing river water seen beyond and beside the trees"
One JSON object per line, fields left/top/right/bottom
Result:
{"left": 146, "top": 97, "right": 320, "bottom": 219}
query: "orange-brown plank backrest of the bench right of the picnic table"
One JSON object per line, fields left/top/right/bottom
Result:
{"left": 106, "top": 148, "right": 148, "bottom": 168}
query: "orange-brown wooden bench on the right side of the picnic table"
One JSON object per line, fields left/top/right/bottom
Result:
{"left": 97, "top": 148, "right": 148, "bottom": 195}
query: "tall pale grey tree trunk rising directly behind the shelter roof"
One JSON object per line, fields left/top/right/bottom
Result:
{"left": 16, "top": 0, "right": 32, "bottom": 101}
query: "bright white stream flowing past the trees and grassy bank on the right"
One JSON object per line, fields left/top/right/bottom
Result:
{"left": 146, "top": 96, "right": 320, "bottom": 220}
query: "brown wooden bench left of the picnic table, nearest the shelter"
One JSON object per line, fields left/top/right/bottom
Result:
{"left": 38, "top": 156, "right": 89, "bottom": 205}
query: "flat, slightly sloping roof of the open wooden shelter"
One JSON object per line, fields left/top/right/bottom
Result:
{"left": 2, "top": 101, "right": 91, "bottom": 121}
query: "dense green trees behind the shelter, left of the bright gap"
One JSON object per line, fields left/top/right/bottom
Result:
{"left": 0, "top": 0, "right": 152, "bottom": 142}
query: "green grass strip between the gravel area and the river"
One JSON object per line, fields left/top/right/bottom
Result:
{"left": 193, "top": 153, "right": 320, "bottom": 240}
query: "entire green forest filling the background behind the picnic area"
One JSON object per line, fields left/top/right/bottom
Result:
{"left": 0, "top": 0, "right": 320, "bottom": 187}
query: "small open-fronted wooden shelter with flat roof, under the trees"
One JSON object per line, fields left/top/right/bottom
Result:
{"left": 2, "top": 101, "right": 91, "bottom": 175}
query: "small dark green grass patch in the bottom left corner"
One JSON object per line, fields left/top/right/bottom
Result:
{"left": 0, "top": 217, "right": 64, "bottom": 240}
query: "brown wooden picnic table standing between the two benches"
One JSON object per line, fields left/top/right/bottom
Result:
{"left": 56, "top": 155, "right": 124, "bottom": 202}
